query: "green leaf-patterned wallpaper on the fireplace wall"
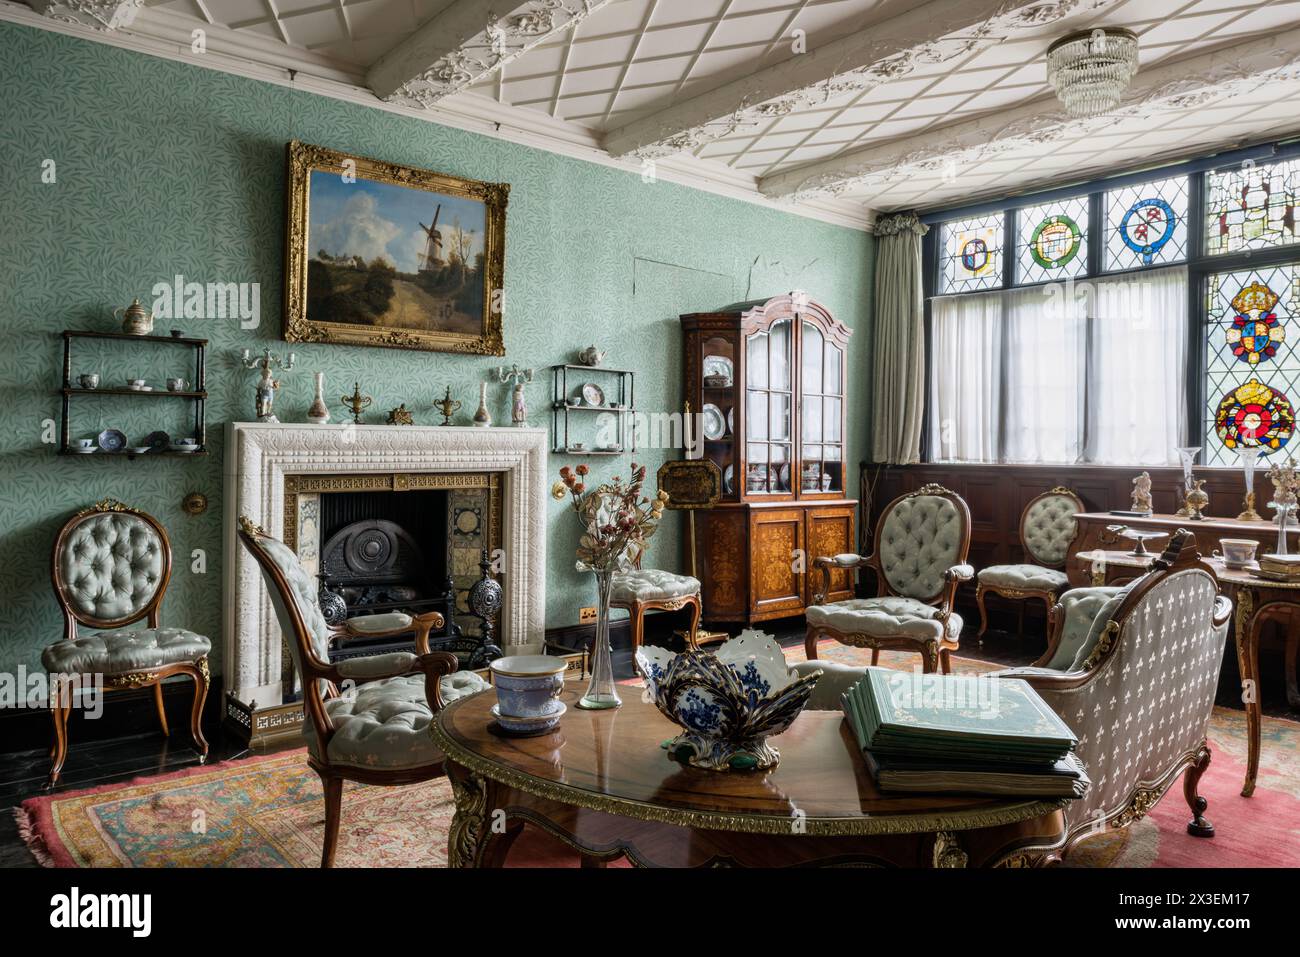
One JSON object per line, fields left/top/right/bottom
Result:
{"left": 0, "top": 23, "right": 872, "bottom": 671}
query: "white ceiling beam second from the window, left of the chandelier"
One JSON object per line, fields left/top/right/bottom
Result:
{"left": 605, "top": 0, "right": 1118, "bottom": 159}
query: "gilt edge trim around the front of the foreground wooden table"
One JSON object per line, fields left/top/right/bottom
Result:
{"left": 429, "top": 690, "right": 1070, "bottom": 837}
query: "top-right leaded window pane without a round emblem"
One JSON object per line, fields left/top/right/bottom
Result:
{"left": 1205, "top": 160, "right": 1300, "bottom": 256}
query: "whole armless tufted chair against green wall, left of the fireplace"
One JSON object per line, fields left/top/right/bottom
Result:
{"left": 40, "top": 498, "right": 212, "bottom": 787}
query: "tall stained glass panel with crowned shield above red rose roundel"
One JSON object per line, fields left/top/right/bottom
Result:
{"left": 1205, "top": 264, "right": 1300, "bottom": 465}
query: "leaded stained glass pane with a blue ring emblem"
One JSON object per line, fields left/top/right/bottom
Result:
{"left": 1104, "top": 176, "right": 1187, "bottom": 270}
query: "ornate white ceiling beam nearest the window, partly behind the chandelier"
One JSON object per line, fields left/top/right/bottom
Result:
{"left": 759, "top": 29, "right": 1300, "bottom": 199}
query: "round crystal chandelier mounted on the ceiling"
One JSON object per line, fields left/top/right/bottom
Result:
{"left": 1048, "top": 27, "right": 1138, "bottom": 117}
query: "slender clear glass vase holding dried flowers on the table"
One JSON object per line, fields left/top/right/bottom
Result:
{"left": 551, "top": 462, "right": 668, "bottom": 709}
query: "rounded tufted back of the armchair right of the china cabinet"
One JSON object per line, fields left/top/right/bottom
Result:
{"left": 876, "top": 486, "right": 971, "bottom": 602}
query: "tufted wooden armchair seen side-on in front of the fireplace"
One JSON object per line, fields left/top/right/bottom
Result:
{"left": 238, "top": 516, "right": 489, "bottom": 867}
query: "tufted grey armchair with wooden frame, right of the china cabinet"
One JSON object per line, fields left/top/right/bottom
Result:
{"left": 805, "top": 485, "right": 975, "bottom": 674}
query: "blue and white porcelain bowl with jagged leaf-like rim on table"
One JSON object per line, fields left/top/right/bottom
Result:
{"left": 636, "top": 631, "right": 822, "bottom": 771}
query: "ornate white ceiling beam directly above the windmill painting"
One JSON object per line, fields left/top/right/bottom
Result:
{"left": 367, "top": 0, "right": 610, "bottom": 108}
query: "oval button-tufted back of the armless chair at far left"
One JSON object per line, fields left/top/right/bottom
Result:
{"left": 51, "top": 499, "right": 172, "bottom": 638}
